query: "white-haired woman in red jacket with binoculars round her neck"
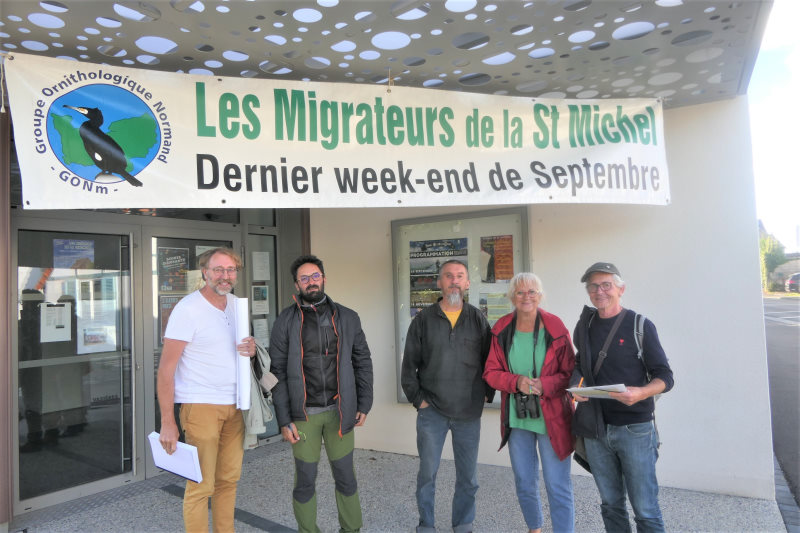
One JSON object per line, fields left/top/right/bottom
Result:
{"left": 483, "top": 272, "right": 575, "bottom": 533}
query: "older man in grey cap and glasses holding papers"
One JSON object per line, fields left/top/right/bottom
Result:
{"left": 571, "top": 262, "right": 673, "bottom": 532}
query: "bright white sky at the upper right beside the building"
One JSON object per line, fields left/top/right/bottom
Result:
{"left": 747, "top": 0, "right": 800, "bottom": 252}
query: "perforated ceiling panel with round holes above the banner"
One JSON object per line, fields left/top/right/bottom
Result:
{"left": 0, "top": 0, "right": 772, "bottom": 107}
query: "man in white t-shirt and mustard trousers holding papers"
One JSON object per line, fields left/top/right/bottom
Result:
{"left": 157, "top": 248, "right": 255, "bottom": 533}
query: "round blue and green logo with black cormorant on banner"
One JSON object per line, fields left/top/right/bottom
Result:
{"left": 47, "top": 84, "right": 161, "bottom": 187}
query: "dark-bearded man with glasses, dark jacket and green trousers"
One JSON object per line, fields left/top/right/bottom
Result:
{"left": 269, "top": 255, "right": 372, "bottom": 532}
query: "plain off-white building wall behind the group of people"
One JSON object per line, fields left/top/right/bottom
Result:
{"left": 311, "top": 97, "right": 774, "bottom": 498}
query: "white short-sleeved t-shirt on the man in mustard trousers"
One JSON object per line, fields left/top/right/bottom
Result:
{"left": 164, "top": 291, "right": 237, "bottom": 405}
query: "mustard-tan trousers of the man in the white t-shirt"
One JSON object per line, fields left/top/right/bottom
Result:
{"left": 180, "top": 403, "right": 244, "bottom": 533}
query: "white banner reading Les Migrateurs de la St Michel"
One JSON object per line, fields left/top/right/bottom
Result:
{"left": 5, "top": 53, "right": 670, "bottom": 209}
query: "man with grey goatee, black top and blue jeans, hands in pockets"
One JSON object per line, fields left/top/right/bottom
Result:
{"left": 401, "top": 260, "right": 494, "bottom": 533}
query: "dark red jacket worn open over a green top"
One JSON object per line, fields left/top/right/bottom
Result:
{"left": 483, "top": 308, "right": 575, "bottom": 461}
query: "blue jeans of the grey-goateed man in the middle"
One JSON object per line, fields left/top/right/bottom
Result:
{"left": 417, "top": 406, "right": 481, "bottom": 533}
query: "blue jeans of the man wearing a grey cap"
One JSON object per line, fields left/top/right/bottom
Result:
{"left": 585, "top": 422, "right": 664, "bottom": 533}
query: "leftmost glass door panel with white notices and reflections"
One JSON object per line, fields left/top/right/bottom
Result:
{"left": 15, "top": 230, "right": 134, "bottom": 500}
